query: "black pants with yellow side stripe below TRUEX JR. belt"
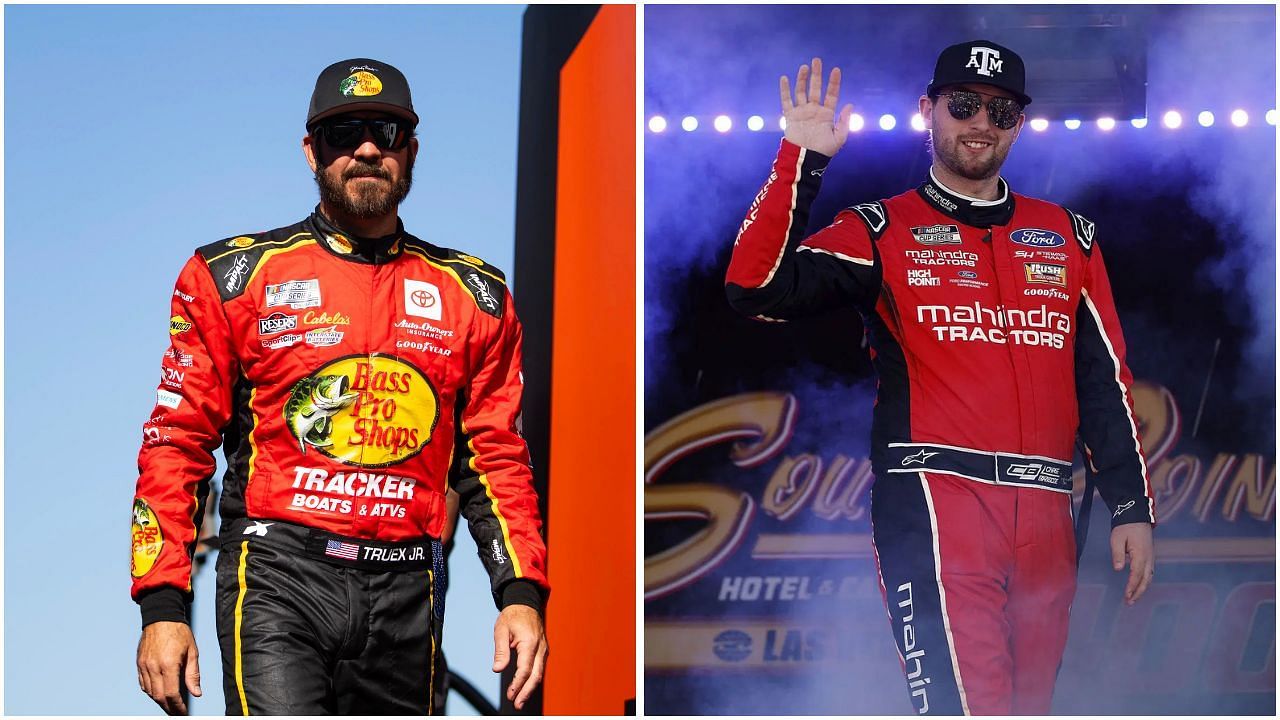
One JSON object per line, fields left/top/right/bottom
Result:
{"left": 218, "top": 521, "right": 444, "bottom": 715}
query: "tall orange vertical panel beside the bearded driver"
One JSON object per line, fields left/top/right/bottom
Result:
{"left": 545, "top": 5, "right": 636, "bottom": 715}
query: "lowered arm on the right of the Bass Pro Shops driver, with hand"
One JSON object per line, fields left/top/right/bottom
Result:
{"left": 451, "top": 283, "right": 549, "bottom": 708}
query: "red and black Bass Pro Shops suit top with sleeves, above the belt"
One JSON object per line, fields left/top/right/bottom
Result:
{"left": 132, "top": 207, "right": 548, "bottom": 624}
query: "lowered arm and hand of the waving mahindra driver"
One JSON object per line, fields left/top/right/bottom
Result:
{"left": 1071, "top": 214, "right": 1156, "bottom": 605}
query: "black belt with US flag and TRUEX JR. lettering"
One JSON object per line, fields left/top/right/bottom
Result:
{"left": 219, "top": 518, "right": 440, "bottom": 571}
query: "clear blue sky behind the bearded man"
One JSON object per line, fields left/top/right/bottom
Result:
{"left": 4, "top": 5, "right": 524, "bottom": 715}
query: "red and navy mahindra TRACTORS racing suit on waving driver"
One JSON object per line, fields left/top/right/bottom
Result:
{"left": 726, "top": 141, "right": 1156, "bottom": 714}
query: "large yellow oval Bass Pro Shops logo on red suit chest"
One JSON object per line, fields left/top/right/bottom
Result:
{"left": 284, "top": 354, "right": 440, "bottom": 468}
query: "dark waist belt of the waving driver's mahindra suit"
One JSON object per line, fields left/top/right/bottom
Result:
{"left": 886, "top": 442, "right": 1071, "bottom": 493}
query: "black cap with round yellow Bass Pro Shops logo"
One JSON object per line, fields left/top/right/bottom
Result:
{"left": 306, "top": 58, "right": 417, "bottom": 129}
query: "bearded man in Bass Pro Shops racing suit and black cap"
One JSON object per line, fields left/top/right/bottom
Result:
{"left": 132, "top": 59, "right": 548, "bottom": 715}
